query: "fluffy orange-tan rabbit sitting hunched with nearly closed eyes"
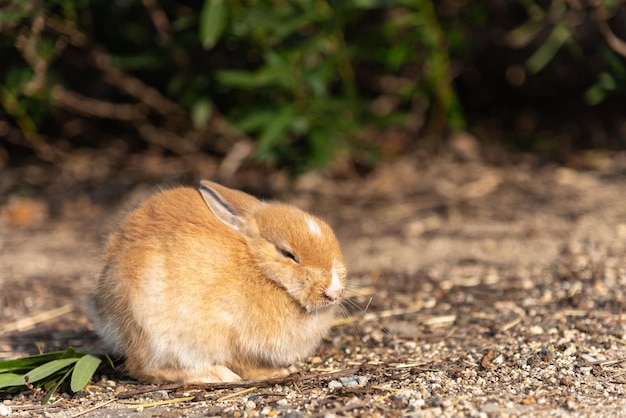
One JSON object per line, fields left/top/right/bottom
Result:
{"left": 90, "top": 180, "right": 347, "bottom": 383}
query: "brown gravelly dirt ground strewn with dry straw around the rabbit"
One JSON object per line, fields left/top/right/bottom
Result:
{"left": 0, "top": 145, "right": 626, "bottom": 418}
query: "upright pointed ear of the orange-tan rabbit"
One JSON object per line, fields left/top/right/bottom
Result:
{"left": 199, "top": 180, "right": 262, "bottom": 233}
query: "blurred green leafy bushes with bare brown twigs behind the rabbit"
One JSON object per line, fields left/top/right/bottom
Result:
{"left": 0, "top": 0, "right": 626, "bottom": 172}
